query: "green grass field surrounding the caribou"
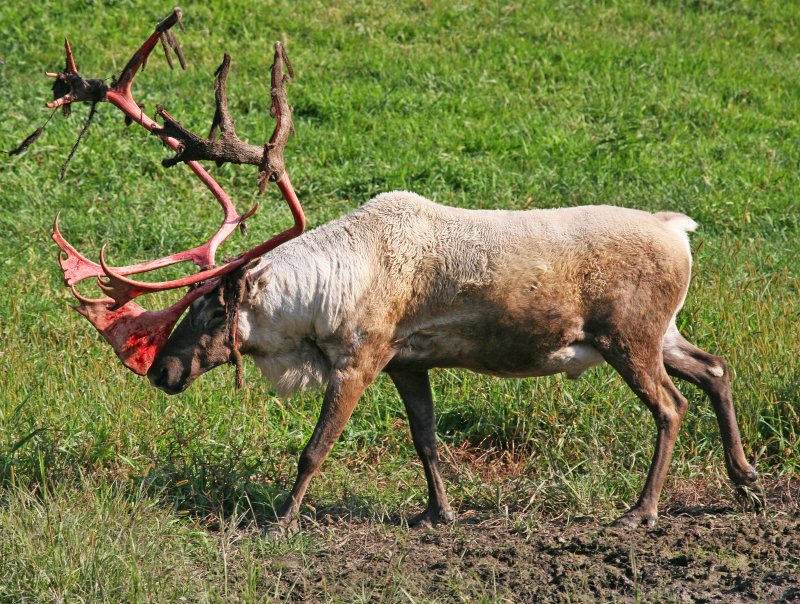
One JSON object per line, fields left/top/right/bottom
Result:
{"left": 0, "top": 0, "right": 800, "bottom": 602}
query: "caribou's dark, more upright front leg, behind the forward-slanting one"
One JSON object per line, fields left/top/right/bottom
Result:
{"left": 389, "top": 371, "right": 455, "bottom": 526}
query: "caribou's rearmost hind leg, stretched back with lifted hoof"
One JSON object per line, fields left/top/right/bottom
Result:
{"left": 664, "top": 323, "right": 758, "bottom": 486}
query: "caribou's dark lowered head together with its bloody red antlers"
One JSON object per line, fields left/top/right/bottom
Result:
{"left": 24, "top": 8, "right": 305, "bottom": 386}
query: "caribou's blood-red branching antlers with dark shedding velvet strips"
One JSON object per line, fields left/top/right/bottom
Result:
{"left": 33, "top": 8, "right": 305, "bottom": 375}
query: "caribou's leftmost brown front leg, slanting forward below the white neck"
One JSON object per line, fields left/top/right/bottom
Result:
{"left": 275, "top": 364, "right": 378, "bottom": 533}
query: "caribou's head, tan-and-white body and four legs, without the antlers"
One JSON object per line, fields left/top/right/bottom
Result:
{"left": 152, "top": 192, "right": 758, "bottom": 528}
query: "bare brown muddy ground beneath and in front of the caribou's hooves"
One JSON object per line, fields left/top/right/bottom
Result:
{"left": 265, "top": 483, "right": 800, "bottom": 603}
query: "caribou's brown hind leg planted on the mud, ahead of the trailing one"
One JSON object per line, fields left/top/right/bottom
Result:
{"left": 597, "top": 338, "right": 688, "bottom": 529}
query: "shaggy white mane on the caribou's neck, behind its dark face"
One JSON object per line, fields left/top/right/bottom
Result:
{"left": 233, "top": 201, "right": 380, "bottom": 396}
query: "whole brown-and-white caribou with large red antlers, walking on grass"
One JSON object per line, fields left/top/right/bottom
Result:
{"left": 23, "top": 10, "right": 758, "bottom": 528}
